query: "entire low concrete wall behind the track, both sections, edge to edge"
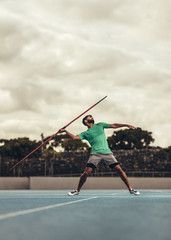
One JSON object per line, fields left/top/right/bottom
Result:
{"left": 0, "top": 177, "right": 171, "bottom": 190}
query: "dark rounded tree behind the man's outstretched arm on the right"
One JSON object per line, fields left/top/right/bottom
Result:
{"left": 108, "top": 128, "right": 154, "bottom": 150}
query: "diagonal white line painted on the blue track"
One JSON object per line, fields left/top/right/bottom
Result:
{"left": 0, "top": 197, "right": 97, "bottom": 220}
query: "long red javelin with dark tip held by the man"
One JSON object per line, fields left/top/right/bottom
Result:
{"left": 9, "top": 96, "right": 107, "bottom": 171}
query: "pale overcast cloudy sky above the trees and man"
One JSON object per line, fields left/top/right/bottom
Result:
{"left": 0, "top": 0, "right": 171, "bottom": 147}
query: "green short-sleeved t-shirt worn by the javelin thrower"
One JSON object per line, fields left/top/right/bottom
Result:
{"left": 78, "top": 122, "right": 111, "bottom": 154}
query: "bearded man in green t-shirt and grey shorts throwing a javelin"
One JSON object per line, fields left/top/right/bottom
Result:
{"left": 59, "top": 115, "right": 140, "bottom": 196}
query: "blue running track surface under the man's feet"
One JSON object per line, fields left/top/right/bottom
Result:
{"left": 0, "top": 190, "right": 171, "bottom": 240}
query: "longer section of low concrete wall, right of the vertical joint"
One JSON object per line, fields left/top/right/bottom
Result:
{"left": 30, "top": 177, "right": 171, "bottom": 190}
